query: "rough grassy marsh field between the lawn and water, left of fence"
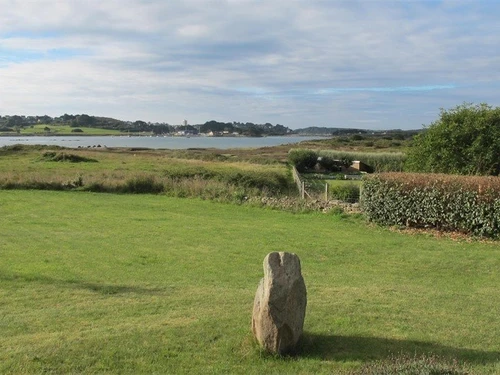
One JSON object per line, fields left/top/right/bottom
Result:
{"left": 0, "top": 146, "right": 296, "bottom": 201}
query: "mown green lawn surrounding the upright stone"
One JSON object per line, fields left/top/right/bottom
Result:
{"left": 0, "top": 191, "right": 500, "bottom": 374}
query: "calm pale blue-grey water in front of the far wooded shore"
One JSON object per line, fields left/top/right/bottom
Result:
{"left": 0, "top": 136, "right": 324, "bottom": 149}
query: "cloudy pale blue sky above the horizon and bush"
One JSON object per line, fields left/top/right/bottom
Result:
{"left": 0, "top": 0, "right": 500, "bottom": 130}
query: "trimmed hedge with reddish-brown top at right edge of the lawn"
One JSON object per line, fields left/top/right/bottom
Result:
{"left": 360, "top": 173, "right": 500, "bottom": 238}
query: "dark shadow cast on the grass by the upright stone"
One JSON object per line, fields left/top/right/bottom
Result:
{"left": 295, "top": 332, "right": 500, "bottom": 363}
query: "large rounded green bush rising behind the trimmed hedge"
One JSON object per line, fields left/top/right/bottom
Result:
{"left": 407, "top": 104, "right": 500, "bottom": 176}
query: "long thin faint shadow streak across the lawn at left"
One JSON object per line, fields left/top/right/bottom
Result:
{"left": 0, "top": 271, "right": 166, "bottom": 295}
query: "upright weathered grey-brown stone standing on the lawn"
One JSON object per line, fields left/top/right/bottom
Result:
{"left": 252, "top": 252, "right": 307, "bottom": 354}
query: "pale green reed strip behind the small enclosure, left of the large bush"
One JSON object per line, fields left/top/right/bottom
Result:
{"left": 319, "top": 150, "right": 406, "bottom": 172}
